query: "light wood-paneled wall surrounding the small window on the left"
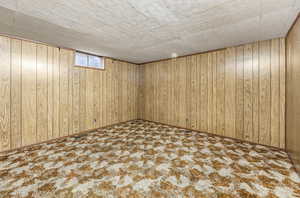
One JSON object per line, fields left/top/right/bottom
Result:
{"left": 0, "top": 36, "right": 138, "bottom": 151}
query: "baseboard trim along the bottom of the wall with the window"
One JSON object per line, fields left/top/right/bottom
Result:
{"left": 0, "top": 119, "right": 138, "bottom": 156}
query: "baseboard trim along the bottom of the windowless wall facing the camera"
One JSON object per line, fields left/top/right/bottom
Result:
{"left": 139, "top": 119, "right": 287, "bottom": 153}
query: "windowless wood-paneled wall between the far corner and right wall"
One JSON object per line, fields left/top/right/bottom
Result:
{"left": 139, "top": 38, "right": 285, "bottom": 148}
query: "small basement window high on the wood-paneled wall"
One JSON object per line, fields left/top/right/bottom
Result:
{"left": 75, "top": 52, "right": 104, "bottom": 69}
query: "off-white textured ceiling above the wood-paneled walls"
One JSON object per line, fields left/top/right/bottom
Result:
{"left": 0, "top": 0, "right": 300, "bottom": 63}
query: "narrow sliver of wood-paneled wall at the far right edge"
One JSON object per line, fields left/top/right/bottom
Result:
{"left": 286, "top": 15, "right": 300, "bottom": 174}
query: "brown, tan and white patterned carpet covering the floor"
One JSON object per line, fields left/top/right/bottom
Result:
{"left": 0, "top": 120, "right": 300, "bottom": 198}
